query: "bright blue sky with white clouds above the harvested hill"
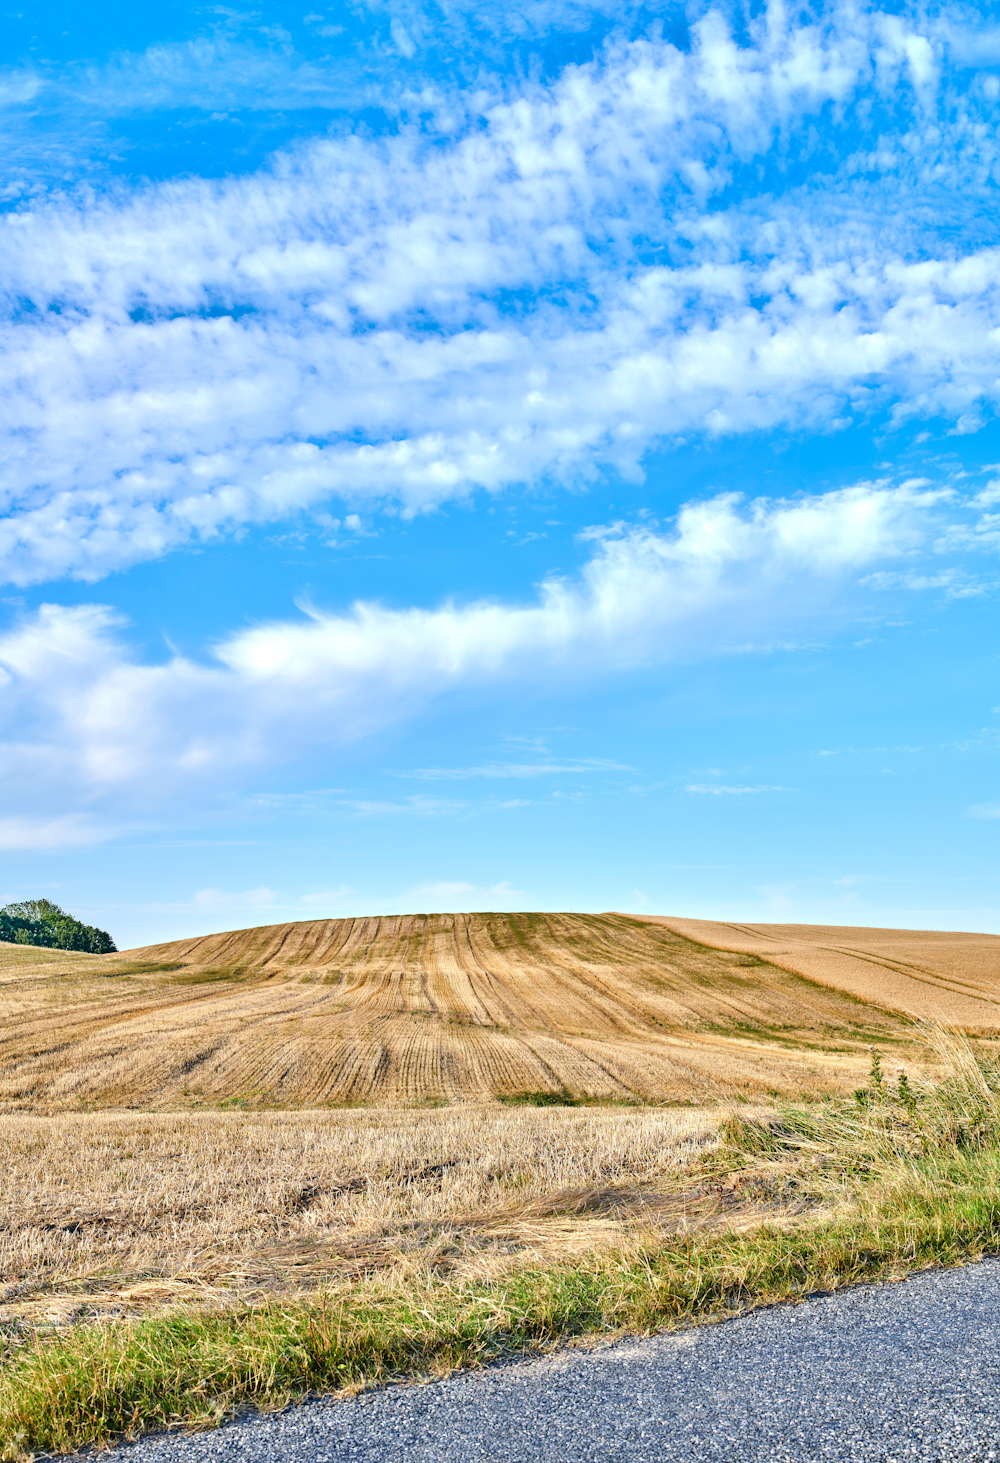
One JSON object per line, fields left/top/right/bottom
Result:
{"left": 0, "top": 0, "right": 1000, "bottom": 945}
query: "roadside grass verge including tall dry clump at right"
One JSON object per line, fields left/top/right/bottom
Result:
{"left": 0, "top": 1033, "right": 1000, "bottom": 1460}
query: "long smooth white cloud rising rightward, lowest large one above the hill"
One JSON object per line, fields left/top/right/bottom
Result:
{"left": 0, "top": 484, "right": 942, "bottom": 841}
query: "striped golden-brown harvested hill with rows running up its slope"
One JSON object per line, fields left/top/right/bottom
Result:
{"left": 0, "top": 914, "right": 929, "bottom": 1112}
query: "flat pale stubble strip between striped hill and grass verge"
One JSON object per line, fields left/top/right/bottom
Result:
{"left": 0, "top": 1107, "right": 719, "bottom": 1325}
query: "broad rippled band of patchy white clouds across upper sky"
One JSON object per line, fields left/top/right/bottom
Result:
{"left": 0, "top": 6, "right": 1000, "bottom": 584}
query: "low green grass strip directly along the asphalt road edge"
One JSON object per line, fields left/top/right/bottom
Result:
{"left": 0, "top": 1176, "right": 1000, "bottom": 1460}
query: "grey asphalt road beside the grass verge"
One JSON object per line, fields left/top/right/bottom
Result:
{"left": 114, "top": 1261, "right": 1000, "bottom": 1463}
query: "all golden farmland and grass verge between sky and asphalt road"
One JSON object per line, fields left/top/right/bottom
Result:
{"left": 0, "top": 914, "right": 1000, "bottom": 1459}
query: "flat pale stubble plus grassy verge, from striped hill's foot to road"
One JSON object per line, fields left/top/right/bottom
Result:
{"left": 7, "top": 1030, "right": 1000, "bottom": 1463}
